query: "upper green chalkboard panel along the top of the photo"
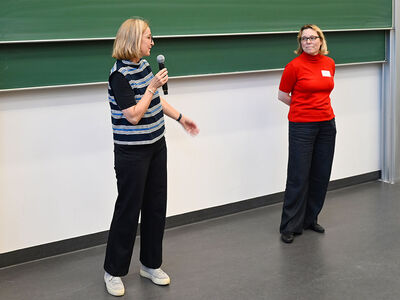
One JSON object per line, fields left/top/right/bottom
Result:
{"left": 0, "top": 0, "right": 392, "bottom": 41}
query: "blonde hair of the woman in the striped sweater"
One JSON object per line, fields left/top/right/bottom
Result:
{"left": 112, "top": 17, "right": 149, "bottom": 60}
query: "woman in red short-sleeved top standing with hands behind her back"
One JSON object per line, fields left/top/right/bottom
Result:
{"left": 278, "top": 24, "right": 336, "bottom": 243}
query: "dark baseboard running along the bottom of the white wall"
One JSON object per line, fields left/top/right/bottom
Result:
{"left": 0, "top": 171, "right": 381, "bottom": 268}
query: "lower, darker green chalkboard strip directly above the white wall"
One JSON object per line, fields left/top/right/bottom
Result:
{"left": 0, "top": 30, "right": 386, "bottom": 89}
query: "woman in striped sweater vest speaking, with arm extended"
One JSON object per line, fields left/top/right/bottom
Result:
{"left": 104, "top": 19, "right": 199, "bottom": 296}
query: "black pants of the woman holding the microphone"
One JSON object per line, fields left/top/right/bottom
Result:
{"left": 104, "top": 138, "right": 167, "bottom": 276}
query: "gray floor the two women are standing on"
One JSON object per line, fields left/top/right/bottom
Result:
{"left": 0, "top": 182, "right": 400, "bottom": 300}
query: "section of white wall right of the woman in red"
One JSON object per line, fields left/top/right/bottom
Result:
{"left": 331, "top": 65, "right": 382, "bottom": 180}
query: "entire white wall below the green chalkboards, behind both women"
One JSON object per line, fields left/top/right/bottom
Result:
{"left": 0, "top": 64, "right": 381, "bottom": 253}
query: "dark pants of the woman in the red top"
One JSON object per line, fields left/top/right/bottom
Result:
{"left": 280, "top": 119, "right": 336, "bottom": 233}
